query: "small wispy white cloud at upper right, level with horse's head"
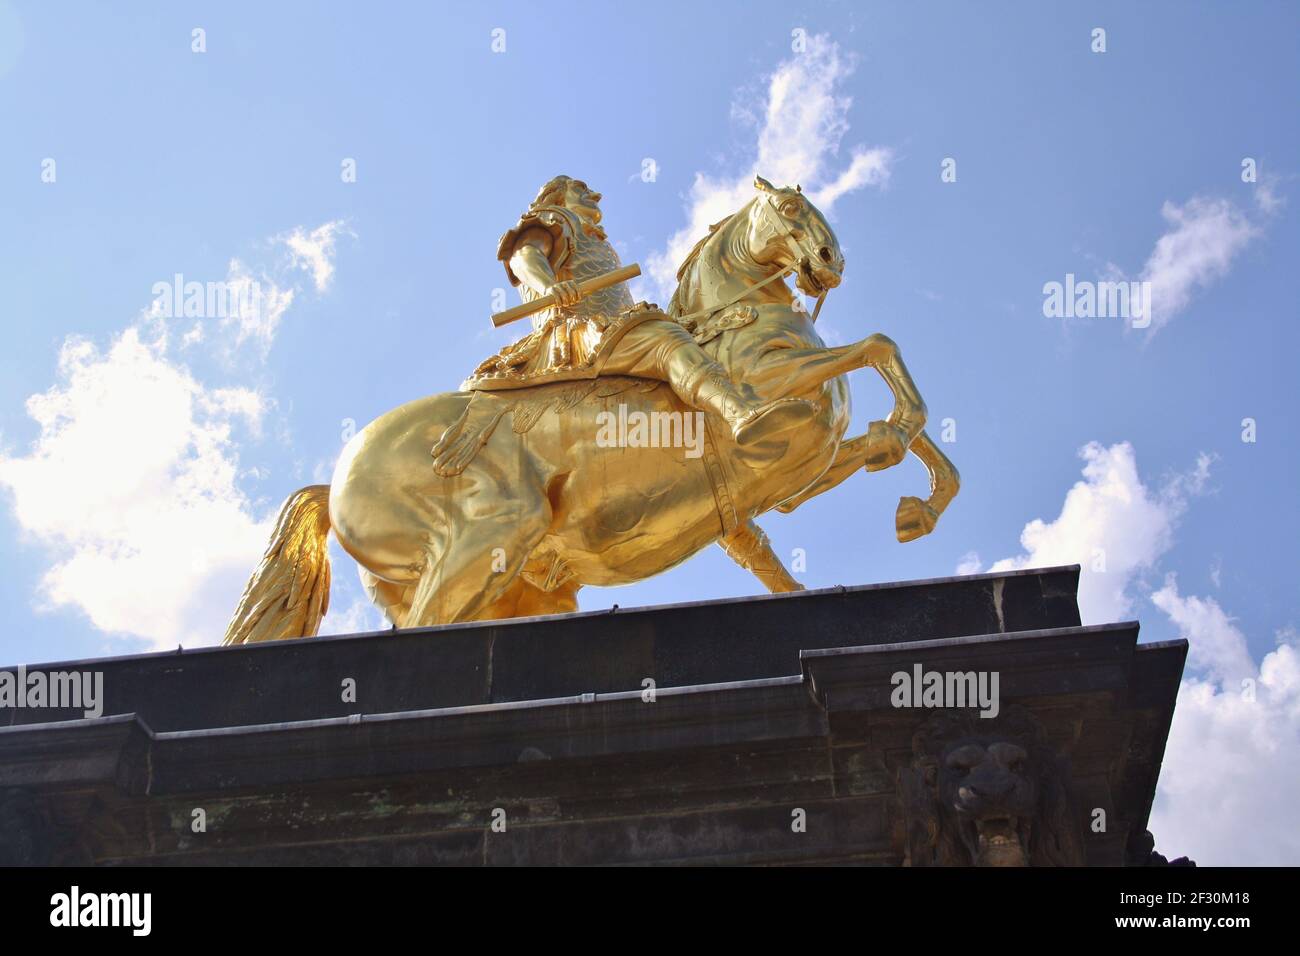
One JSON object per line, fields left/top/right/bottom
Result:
{"left": 1139, "top": 194, "right": 1253, "bottom": 334}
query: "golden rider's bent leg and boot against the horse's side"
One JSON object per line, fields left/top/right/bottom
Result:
{"left": 602, "top": 319, "right": 816, "bottom": 445}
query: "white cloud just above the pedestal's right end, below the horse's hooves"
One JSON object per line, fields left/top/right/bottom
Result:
{"left": 957, "top": 442, "right": 1212, "bottom": 624}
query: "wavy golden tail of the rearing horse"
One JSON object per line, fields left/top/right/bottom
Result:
{"left": 221, "top": 485, "right": 330, "bottom": 644}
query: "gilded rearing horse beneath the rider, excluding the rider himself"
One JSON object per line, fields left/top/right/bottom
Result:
{"left": 225, "top": 179, "right": 958, "bottom": 644}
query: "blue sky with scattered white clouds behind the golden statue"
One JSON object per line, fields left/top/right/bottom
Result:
{"left": 0, "top": 3, "right": 1300, "bottom": 862}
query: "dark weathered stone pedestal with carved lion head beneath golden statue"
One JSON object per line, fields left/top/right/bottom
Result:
{"left": 0, "top": 567, "right": 1187, "bottom": 866}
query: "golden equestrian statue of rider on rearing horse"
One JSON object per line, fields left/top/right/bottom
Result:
{"left": 224, "top": 176, "right": 958, "bottom": 644}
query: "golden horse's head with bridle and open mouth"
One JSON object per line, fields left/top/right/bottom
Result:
{"left": 748, "top": 176, "right": 844, "bottom": 295}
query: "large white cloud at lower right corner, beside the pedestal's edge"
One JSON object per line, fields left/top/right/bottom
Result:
{"left": 1149, "top": 624, "right": 1300, "bottom": 866}
